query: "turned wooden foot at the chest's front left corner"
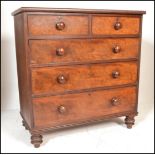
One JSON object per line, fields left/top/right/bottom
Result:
{"left": 31, "top": 134, "right": 43, "bottom": 148}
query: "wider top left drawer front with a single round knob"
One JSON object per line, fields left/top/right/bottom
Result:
{"left": 28, "top": 15, "right": 88, "bottom": 35}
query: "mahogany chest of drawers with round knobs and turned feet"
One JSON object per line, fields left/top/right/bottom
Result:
{"left": 12, "top": 8, "right": 145, "bottom": 147}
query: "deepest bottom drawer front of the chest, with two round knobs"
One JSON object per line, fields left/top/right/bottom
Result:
{"left": 33, "top": 87, "right": 136, "bottom": 127}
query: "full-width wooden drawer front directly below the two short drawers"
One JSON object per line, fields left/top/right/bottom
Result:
{"left": 29, "top": 38, "right": 139, "bottom": 64}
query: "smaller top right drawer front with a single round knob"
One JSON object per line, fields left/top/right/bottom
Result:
{"left": 92, "top": 16, "right": 140, "bottom": 35}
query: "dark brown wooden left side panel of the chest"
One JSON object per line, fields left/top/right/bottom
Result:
{"left": 14, "top": 14, "right": 32, "bottom": 127}
